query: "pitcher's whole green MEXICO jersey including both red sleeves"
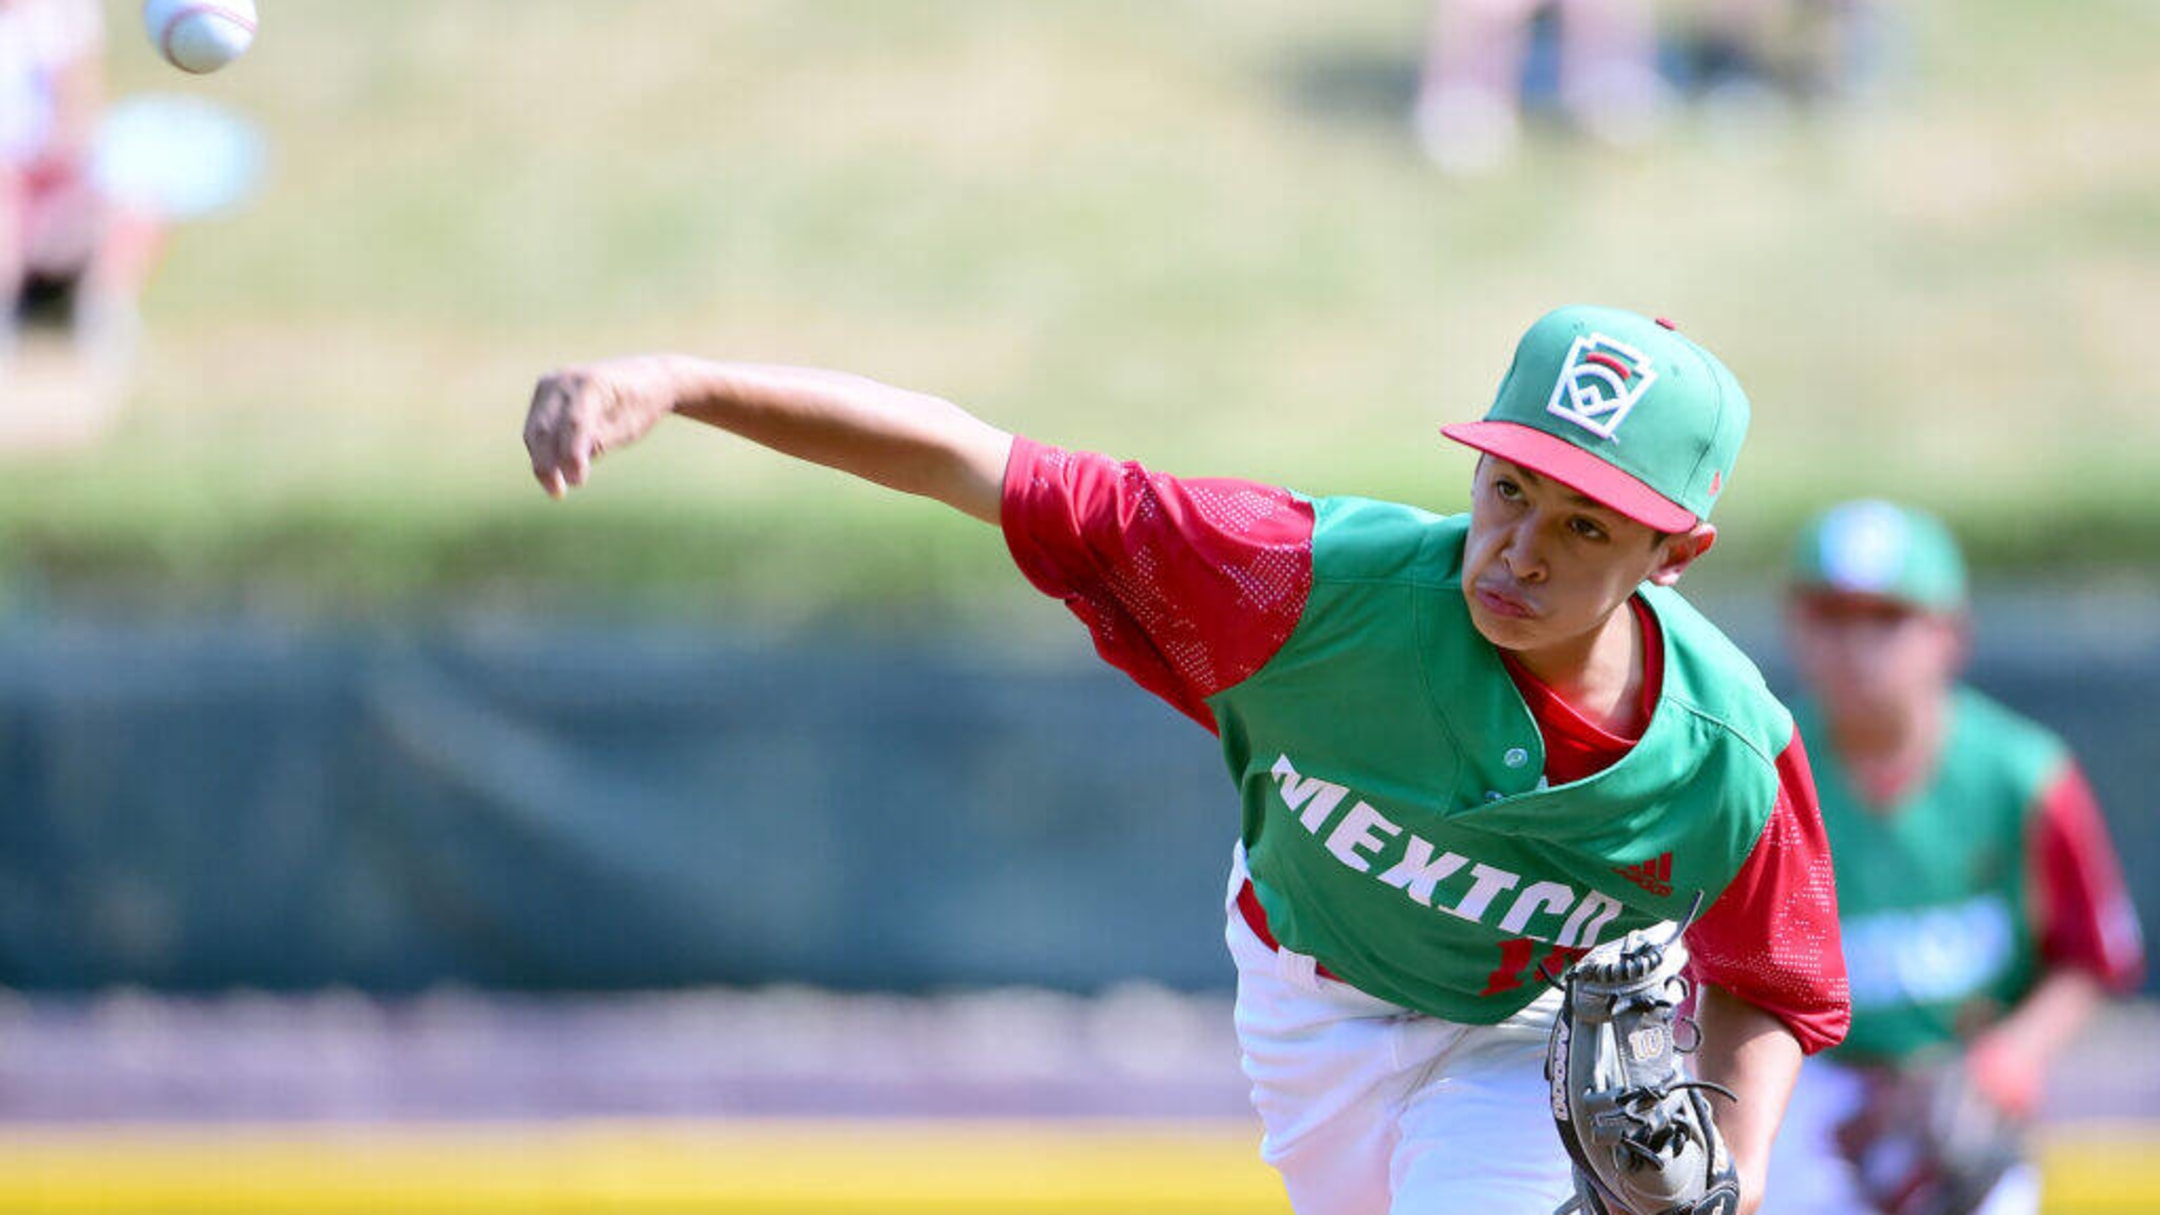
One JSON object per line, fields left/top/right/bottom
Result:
{"left": 1004, "top": 439, "right": 1845, "bottom": 1051}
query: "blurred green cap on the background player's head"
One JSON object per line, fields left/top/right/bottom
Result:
{"left": 1791, "top": 499, "right": 1966, "bottom": 612}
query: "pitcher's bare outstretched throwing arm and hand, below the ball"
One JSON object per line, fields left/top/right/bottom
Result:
{"left": 525, "top": 355, "right": 1013, "bottom": 525}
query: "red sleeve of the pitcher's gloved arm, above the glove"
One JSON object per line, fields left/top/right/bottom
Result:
{"left": 1687, "top": 731, "right": 1853, "bottom": 1055}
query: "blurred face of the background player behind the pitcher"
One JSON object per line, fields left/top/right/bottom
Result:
{"left": 1786, "top": 592, "right": 1966, "bottom": 724}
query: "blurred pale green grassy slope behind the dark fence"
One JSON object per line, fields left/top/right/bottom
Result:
{"left": 0, "top": 0, "right": 2160, "bottom": 618}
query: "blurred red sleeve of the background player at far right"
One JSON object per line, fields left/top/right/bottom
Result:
{"left": 2026, "top": 761, "right": 2145, "bottom": 992}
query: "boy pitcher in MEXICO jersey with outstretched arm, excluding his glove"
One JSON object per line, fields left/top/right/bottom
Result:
{"left": 525, "top": 307, "right": 1847, "bottom": 1215}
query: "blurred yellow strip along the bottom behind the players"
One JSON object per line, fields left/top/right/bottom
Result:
{"left": 0, "top": 1120, "right": 2160, "bottom": 1215}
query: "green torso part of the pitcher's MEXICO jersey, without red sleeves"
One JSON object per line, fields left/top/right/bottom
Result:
{"left": 1210, "top": 499, "right": 1793, "bottom": 1025}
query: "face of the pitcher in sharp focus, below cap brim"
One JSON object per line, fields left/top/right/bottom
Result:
{"left": 1462, "top": 456, "right": 1717, "bottom": 668}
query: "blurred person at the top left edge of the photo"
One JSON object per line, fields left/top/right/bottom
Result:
{"left": 0, "top": 0, "right": 158, "bottom": 376}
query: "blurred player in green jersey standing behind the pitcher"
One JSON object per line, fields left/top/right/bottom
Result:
{"left": 1765, "top": 502, "right": 2143, "bottom": 1215}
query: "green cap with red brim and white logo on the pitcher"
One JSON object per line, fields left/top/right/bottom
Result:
{"left": 1441, "top": 305, "right": 1747, "bottom": 532}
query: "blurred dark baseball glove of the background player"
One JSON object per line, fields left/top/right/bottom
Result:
{"left": 1836, "top": 1057, "right": 2024, "bottom": 1215}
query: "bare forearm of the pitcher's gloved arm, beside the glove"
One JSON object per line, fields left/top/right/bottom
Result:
{"left": 1696, "top": 986, "right": 1801, "bottom": 1215}
